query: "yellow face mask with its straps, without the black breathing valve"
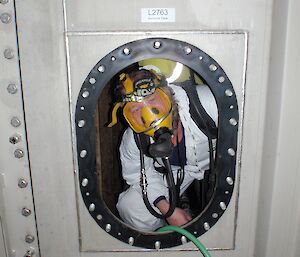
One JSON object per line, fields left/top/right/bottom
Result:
{"left": 108, "top": 71, "right": 172, "bottom": 136}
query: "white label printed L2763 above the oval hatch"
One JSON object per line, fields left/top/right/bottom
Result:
{"left": 141, "top": 8, "right": 175, "bottom": 22}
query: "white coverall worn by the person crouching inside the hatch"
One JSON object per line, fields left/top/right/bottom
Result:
{"left": 117, "top": 85, "right": 218, "bottom": 231}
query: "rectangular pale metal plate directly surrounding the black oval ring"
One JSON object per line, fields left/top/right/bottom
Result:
{"left": 67, "top": 31, "right": 247, "bottom": 251}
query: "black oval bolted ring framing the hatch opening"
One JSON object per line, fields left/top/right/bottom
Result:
{"left": 75, "top": 38, "right": 239, "bottom": 249}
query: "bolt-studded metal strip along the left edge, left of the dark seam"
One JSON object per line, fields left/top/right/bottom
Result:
{"left": 0, "top": 1, "right": 39, "bottom": 256}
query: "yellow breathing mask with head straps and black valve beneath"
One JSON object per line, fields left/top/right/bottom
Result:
{"left": 108, "top": 70, "right": 172, "bottom": 157}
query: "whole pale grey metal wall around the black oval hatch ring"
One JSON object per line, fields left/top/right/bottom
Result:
{"left": 0, "top": 0, "right": 300, "bottom": 257}
